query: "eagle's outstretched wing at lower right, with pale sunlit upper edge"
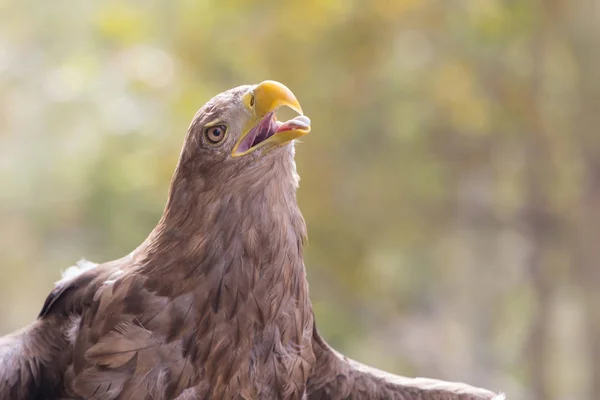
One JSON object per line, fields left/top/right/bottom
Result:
{"left": 308, "top": 327, "right": 504, "bottom": 400}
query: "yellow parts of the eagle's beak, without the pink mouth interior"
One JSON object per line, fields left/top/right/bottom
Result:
{"left": 231, "top": 81, "right": 310, "bottom": 157}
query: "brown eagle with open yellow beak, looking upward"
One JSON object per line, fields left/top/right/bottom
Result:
{"left": 0, "top": 81, "right": 502, "bottom": 400}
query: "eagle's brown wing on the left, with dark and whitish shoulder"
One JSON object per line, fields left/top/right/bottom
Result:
{"left": 0, "top": 262, "right": 122, "bottom": 400}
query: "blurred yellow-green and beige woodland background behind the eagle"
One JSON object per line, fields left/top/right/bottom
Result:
{"left": 0, "top": 0, "right": 600, "bottom": 400}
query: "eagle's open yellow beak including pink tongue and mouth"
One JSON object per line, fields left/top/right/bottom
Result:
{"left": 231, "top": 81, "right": 310, "bottom": 157}
